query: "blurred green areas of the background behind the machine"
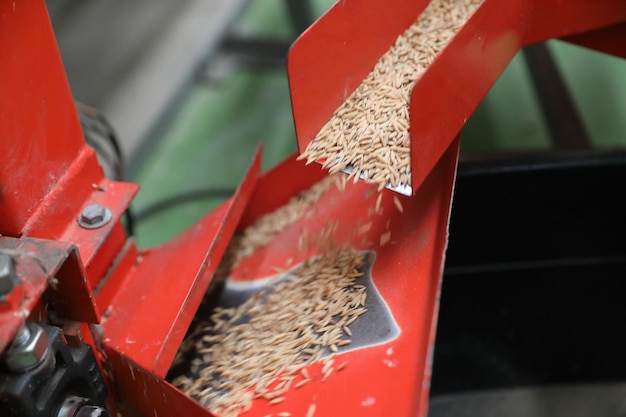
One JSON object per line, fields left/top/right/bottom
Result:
{"left": 129, "top": 0, "right": 626, "bottom": 247}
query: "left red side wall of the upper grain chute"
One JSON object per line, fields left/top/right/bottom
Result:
{"left": 287, "top": 0, "right": 428, "bottom": 152}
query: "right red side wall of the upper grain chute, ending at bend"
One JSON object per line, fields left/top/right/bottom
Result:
{"left": 409, "top": 0, "right": 526, "bottom": 193}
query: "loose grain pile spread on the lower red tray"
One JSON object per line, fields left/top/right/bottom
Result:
{"left": 173, "top": 250, "right": 367, "bottom": 416}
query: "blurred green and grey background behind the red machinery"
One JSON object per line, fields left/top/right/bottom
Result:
{"left": 48, "top": 0, "right": 626, "bottom": 247}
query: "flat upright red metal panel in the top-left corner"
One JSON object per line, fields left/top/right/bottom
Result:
{"left": 0, "top": 0, "right": 89, "bottom": 236}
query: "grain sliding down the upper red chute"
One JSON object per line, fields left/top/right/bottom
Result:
{"left": 300, "top": 0, "right": 482, "bottom": 189}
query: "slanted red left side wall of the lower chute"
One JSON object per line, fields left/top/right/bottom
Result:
{"left": 102, "top": 149, "right": 261, "bottom": 376}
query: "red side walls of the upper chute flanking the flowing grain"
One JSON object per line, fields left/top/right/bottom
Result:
{"left": 287, "top": 0, "right": 626, "bottom": 194}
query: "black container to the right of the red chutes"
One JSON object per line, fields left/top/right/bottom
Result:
{"left": 431, "top": 151, "right": 626, "bottom": 398}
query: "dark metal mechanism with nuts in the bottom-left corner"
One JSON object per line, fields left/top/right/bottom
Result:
{"left": 0, "top": 322, "right": 109, "bottom": 417}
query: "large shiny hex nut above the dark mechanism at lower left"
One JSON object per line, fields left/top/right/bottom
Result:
{"left": 4, "top": 322, "right": 48, "bottom": 372}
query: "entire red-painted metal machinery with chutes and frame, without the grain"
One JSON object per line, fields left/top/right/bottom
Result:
{"left": 0, "top": 0, "right": 626, "bottom": 417}
